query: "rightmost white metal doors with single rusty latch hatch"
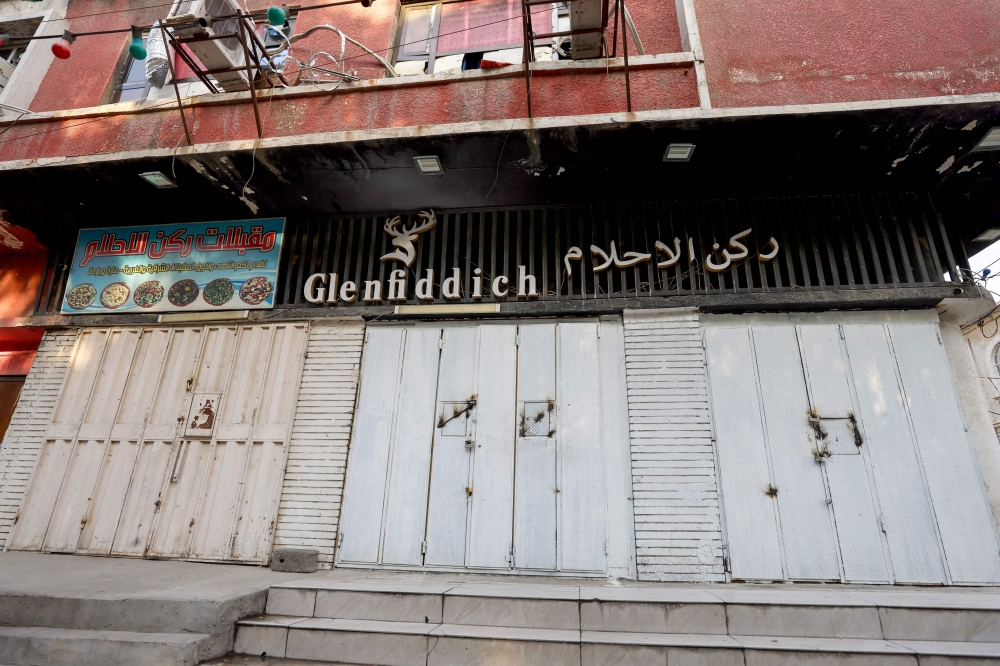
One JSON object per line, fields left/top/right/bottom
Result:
{"left": 702, "top": 311, "right": 1000, "bottom": 584}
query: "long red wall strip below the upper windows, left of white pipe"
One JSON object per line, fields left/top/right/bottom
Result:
{"left": 0, "top": 68, "right": 698, "bottom": 161}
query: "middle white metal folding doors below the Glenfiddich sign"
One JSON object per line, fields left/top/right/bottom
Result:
{"left": 338, "top": 319, "right": 634, "bottom": 575}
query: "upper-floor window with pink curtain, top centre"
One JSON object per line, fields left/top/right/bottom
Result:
{"left": 394, "top": 0, "right": 568, "bottom": 74}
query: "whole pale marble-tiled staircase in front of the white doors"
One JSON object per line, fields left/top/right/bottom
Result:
{"left": 233, "top": 577, "right": 1000, "bottom": 666}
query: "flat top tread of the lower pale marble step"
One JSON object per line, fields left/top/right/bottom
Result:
{"left": 237, "top": 615, "right": 1000, "bottom": 659}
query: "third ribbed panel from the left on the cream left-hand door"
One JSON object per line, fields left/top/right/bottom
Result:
{"left": 78, "top": 328, "right": 171, "bottom": 555}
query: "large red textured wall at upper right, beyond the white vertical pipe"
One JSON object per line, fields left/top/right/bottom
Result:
{"left": 695, "top": 0, "right": 1000, "bottom": 107}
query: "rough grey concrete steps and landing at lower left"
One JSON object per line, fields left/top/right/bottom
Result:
{"left": 0, "top": 553, "right": 302, "bottom": 666}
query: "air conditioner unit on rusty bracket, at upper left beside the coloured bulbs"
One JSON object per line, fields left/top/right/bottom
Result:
{"left": 167, "top": 0, "right": 253, "bottom": 92}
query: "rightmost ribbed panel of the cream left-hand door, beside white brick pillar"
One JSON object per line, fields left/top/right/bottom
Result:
{"left": 229, "top": 324, "right": 309, "bottom": 563}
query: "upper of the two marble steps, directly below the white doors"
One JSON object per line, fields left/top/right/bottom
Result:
{"left": 266, "top": 578, "right": 1000, "bottom": 643}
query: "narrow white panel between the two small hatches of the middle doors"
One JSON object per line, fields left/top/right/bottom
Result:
{"left": 468, "top": 324, "right": 516, "bottom": 568}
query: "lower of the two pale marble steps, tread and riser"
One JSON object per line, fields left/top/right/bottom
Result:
{"left": 235, "top": 615, "right": 1000, "bottom": 666}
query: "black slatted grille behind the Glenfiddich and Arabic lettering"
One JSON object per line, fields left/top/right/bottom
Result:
{"left": 278, "top": 193, "right": 960, "bottom": 307}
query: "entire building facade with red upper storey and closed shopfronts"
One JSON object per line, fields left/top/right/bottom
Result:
{"left": 0, "top": 0, "right": 1000, "bottom": 585}
